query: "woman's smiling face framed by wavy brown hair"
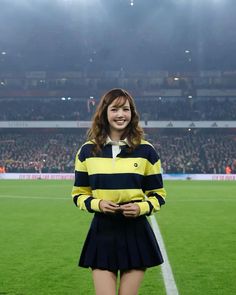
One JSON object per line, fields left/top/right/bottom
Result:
{"left": 107, "top": 97, "right": 131, "bottom": 135}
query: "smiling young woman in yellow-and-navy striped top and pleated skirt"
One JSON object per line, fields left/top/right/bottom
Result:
{"left": 72, "top": 89, "right": 166, "bottom": 295}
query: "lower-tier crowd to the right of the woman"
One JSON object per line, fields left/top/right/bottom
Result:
{"left": 153, "top": 132, "right": 236, "bottom": 174}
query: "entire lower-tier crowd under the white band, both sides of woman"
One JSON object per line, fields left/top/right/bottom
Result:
{"left": 0, "top": 129, "right": 236, "bottom": 174}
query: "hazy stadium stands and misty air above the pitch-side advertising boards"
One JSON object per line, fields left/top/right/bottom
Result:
{"left": 0, "top": 0, "right": 236, "bottom": 174}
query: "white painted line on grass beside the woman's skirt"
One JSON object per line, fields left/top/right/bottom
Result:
{"left": 150, "top": 216, "right": 179, "bottom": 295}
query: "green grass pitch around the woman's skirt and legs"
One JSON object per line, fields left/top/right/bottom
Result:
{"left": 0, "top": 180, "right": 236, "bottom": 295}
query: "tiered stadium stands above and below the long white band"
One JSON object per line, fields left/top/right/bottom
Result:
{"left": 0, "top": 71, "right": 236, "bottom": 174}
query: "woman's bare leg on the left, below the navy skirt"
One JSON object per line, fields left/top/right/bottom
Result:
{"left": 93, "top": 269, "right": 117, "bottom": 295}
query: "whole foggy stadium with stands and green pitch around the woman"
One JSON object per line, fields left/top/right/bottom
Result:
{"left": 0, "top": 0, "right": 236, "bottom": 295}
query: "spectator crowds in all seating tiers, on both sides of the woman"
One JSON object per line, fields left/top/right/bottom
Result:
{"left": 0, "top": 71, "right": 236, "bottom": 173}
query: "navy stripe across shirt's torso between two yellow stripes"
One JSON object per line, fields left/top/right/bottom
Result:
{"left": 90, "top": 173, "right": 143, "bottom": 190}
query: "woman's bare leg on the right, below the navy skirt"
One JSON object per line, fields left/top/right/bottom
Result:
{"left": 119, "top": 269, "right": 145, "bottom": 295}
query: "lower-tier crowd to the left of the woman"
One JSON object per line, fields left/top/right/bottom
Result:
{"left": 0, "top": 133, "right": 84, "bottom": 173}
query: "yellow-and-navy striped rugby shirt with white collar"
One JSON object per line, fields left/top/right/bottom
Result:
{"left": 72, "top": 139, "right": 166, "bottom": 215}
